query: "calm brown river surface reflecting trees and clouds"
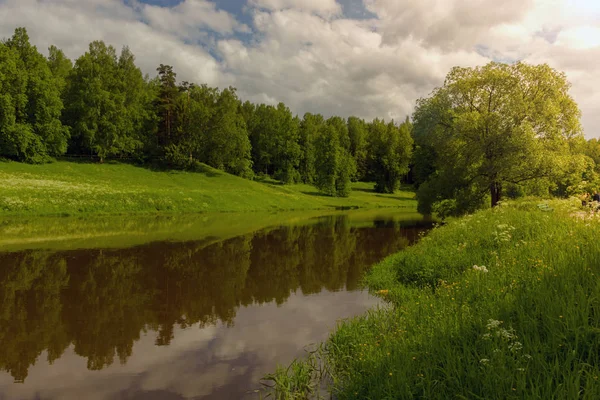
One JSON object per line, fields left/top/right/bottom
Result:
{"left": 0, "top": 211, "right": 428, "bottom": 399}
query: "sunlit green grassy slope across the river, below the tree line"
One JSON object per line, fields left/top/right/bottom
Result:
{"left": 0, "top": 162, "right": 416, "bottom": 215}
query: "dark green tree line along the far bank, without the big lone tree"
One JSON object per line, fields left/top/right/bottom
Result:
{"left": 0, "top": 28, "right": 413, "bottom": 196}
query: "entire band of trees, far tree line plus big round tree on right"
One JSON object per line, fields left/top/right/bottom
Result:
{"left": 0, "top": 28, "right": 600, "bottom": 217}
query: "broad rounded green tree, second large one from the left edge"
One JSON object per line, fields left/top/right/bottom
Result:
{"left": 65, "top": 41, "right": 152, "bottom": 162}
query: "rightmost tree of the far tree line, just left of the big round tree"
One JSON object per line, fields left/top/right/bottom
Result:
{"left": 368, "top": 118, "right": 413, "bottom": 193}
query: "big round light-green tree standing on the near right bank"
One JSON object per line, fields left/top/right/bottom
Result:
{"left": 413, "top": 62, "right": 581, "bottom": 214}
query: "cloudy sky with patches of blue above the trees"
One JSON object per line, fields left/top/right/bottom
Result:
{"left": 0, "top": 0, "right": 600, "bottom": 138}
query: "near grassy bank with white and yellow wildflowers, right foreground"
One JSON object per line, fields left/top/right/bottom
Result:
{"left": 272, "top": 201, "right": 600, "bottom": 399}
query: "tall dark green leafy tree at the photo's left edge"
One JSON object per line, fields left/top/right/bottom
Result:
{"left": 0, "top": 28, "right": 69, "bottom": 162}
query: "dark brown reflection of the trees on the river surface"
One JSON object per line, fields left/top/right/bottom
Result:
{"left": 0, "top": 216, "right": 424, "bottom": 382}
